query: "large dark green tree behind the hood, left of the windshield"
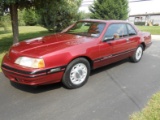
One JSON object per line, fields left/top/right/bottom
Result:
{"left": 36, "top": 0, "right": 82, "bottom": 32}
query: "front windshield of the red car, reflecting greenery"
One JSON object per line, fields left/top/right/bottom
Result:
{"left": 66, "top": 21, "right": 105, "bottom": 37}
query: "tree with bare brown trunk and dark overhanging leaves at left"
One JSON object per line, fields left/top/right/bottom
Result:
{"left": 0, "top": 0, "right": 34, "bottom": 43}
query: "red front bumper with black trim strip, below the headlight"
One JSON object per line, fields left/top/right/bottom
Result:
{"left": 1, "top": 64, "right": 65, "bottom": 85}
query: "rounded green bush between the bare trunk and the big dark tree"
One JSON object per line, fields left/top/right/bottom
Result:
{"left": 23, "top": 8, "right": 37, "bottom": 26}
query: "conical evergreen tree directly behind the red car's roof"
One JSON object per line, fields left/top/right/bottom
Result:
{"left": 90, "top": 0, "right": 129, "bottom": 20}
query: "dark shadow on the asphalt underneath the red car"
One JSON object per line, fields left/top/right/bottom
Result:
{"left": 10, "top": 59, "right": 129, "bottom": 94}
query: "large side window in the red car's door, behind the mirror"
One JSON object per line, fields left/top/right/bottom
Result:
{"left": 105, "top": 24, "right": 128, "bottom": 39}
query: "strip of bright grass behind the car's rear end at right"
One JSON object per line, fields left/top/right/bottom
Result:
{"left": 137, "top": 26, "right": 160, "bottom": 35}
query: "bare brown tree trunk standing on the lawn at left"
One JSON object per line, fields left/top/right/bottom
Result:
{"left": 10, "top": 4, "right": 19, "bottom": 44}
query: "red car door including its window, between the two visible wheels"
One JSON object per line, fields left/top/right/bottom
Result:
{"left": 101, "top": 23, "right": 131, "bottom": 64}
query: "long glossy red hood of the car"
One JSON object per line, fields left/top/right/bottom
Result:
{"left": 10, "top": 33, "right": 94, "bottom": 56}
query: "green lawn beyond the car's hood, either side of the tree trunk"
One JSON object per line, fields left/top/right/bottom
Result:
{"left": 0, "top": 26, "right": 51, "bottom": 71}
